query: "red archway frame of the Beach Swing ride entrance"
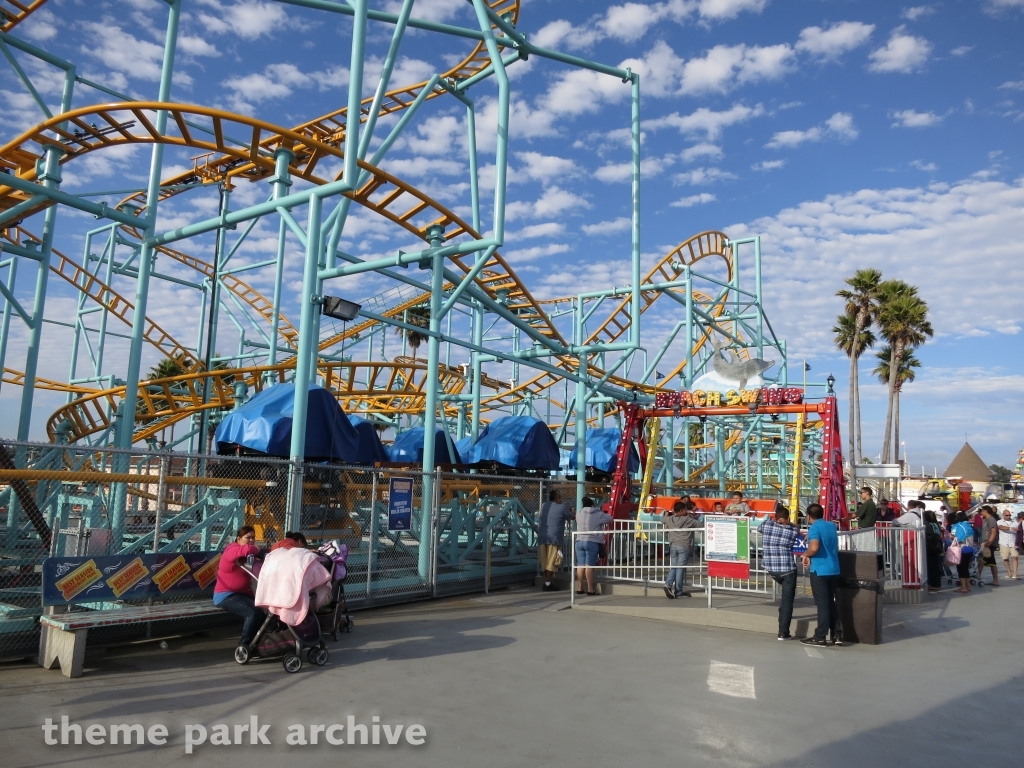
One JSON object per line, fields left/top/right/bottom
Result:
{"left": 604, "top": 387, "right": 850, "bottom": 530}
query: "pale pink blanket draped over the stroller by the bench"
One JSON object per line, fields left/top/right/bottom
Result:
{"left": 256, "top": 547, "right": 331, "bottom": 626}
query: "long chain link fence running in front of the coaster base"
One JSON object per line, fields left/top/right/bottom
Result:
{"left": 0, "top": 441, "right": 608, "bottom": 657}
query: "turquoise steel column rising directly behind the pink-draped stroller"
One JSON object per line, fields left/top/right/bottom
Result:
{"left": 286, "top": 195, "right": 324, "bottom": 530}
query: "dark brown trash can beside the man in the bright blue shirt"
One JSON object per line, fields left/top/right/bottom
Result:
{"left": 836, "top": 552, "right": 885, "bottom": 645}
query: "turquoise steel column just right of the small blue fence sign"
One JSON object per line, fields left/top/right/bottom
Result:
{"left": 417, "top": 224, "right": 444, "bottom": 582}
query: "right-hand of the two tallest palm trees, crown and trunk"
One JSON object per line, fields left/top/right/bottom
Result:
{"left": 878, "top": 281, "right": 934, "bottom": 463}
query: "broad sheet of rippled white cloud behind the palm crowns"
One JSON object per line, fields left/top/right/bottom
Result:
{"left": 725, "top": 177, "right": 1024, "bottom": 359}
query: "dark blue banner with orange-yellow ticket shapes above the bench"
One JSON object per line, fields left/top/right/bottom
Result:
{"left": 43, "top": 552, "right": 220, "bottom": 605}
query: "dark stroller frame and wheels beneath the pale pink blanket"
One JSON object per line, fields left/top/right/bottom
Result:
{"left": 234, "top": 553, "right": 333, "bottom": 673}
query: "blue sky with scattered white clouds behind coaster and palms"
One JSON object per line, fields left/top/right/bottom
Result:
{"left": 0, "top": 0, "right": 1024, "bottom": 472}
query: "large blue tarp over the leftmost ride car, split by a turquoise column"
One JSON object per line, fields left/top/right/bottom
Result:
{"left": 216, "top": 382, "right": 362, "bottom": 464}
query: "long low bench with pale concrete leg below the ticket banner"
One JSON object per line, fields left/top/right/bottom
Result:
{"left": 39, "top": 600, "right": 224, "bottom": 678}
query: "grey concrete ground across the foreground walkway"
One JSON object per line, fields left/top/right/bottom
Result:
{"left": 0, "top": 581, "right": 1024, "bottom": 768}
